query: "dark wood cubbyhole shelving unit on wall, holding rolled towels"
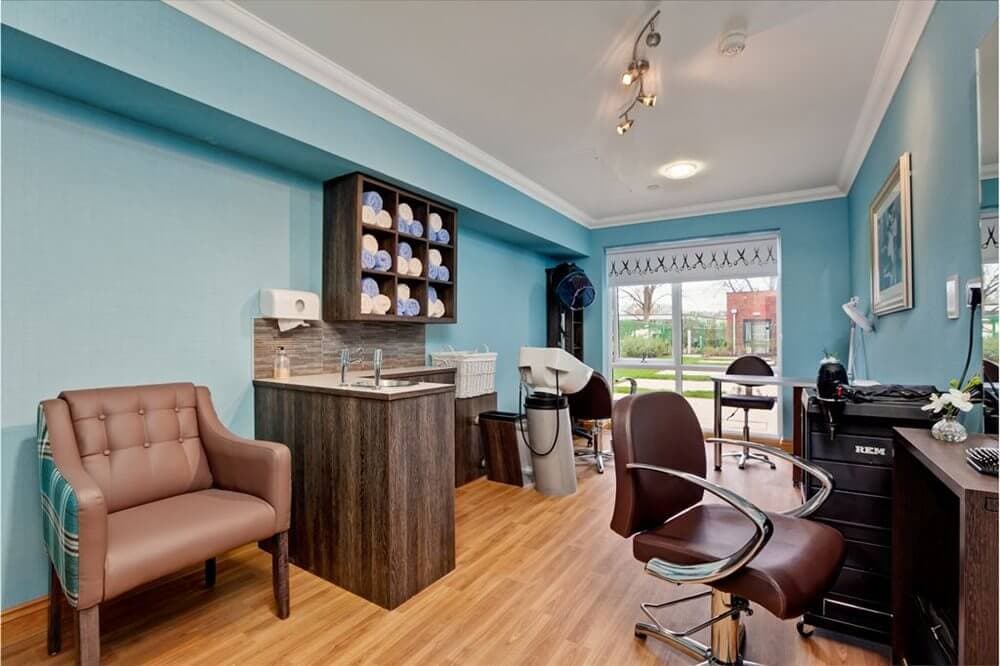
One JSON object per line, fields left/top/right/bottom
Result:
{"left": 323, "top": 173, "right": 458, "bottom": 324}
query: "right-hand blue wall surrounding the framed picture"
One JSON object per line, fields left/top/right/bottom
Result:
{"left": 848, "top": 2, "right": 997, "bottom": 386}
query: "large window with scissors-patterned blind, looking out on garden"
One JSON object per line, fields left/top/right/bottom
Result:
{"left": 608, "top": 236, "right": 781, "bottom": 437}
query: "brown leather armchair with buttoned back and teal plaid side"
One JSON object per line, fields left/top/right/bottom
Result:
{"left": 38, "top": 384, "right": 291, "bottom": 664}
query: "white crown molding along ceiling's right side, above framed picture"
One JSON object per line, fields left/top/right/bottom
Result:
{"left": 837, "top": 0, "right": 937, "bottom": 192}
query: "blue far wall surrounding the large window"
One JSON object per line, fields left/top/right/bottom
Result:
{"left": 581, "top": 198, "right": 851, "bottom": 437}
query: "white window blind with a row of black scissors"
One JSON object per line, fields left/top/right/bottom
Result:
{"left": 607, "top": 235, "right": 778, "bottom": 286}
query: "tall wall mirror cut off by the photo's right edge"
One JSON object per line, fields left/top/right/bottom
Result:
{"left": 976, "top": 22, "right": 1000, "bottom": 433}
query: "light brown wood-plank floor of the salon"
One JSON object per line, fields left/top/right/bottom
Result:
{"left": 2, "top": 444, "right": 887, "bottom": 666}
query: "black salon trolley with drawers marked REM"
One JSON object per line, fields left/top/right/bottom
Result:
{"left": 802, "top": 389, "right": 932, "bottom": 644}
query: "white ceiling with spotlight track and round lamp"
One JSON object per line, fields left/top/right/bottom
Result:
{"left": 184, "top": 0, "right": 916, "bottom": 226}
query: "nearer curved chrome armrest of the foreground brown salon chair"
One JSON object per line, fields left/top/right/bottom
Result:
{"left": 627, "top": 463, "right": 774, "bottom": 585}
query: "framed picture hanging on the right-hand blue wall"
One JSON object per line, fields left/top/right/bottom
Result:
{"left": 869, "top": 153, "right": 913, "bottom": 315}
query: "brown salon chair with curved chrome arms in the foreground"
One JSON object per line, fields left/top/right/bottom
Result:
{"left": 611, "top": 392, "right": 844, "bottom": 664}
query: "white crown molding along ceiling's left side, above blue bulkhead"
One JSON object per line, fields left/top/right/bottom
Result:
{"left": 164, "top": 0, "right": 592, "bottom": 226}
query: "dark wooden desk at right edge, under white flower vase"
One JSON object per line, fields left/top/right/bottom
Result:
{"left": 892, "top": 428, "right": 1000, "bottom": 664}
